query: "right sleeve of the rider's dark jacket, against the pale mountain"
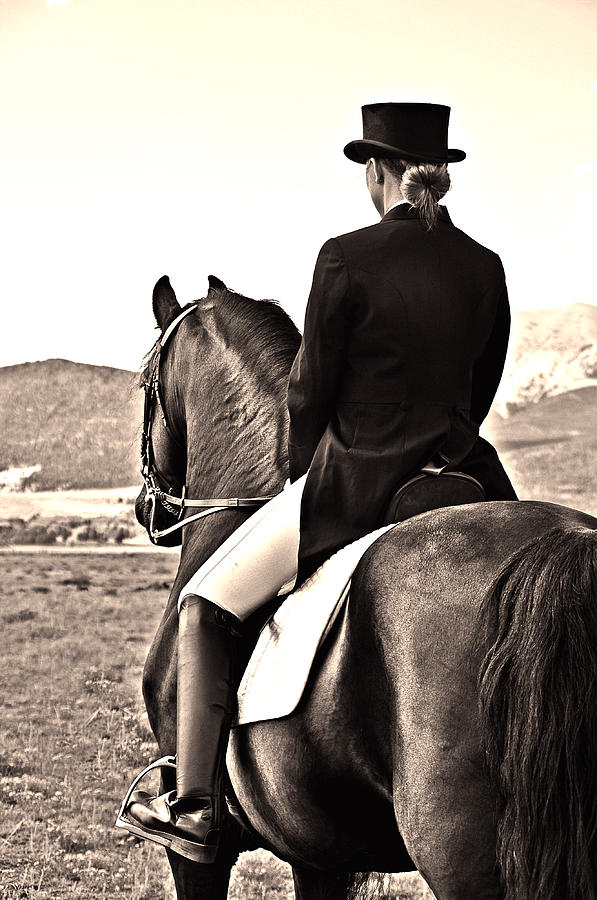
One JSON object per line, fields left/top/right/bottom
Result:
{"left": 471, "top": 263, "right": 510, "bottom": 425}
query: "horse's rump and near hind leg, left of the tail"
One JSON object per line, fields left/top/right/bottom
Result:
{"left": 353, "top": 501, "right": 597, "bottom": 900}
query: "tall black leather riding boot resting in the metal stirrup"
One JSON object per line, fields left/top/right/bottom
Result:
{"left": 117, "top": 594, "right": 242, "bottom": 863}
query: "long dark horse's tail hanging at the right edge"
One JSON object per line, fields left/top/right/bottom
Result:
{"left": 479, "top": 527, "right": 597, "bottom": 900}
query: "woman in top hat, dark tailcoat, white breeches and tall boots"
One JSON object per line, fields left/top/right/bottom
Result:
{"left": 120, "top": 103, "right": 516, "bottom": 862}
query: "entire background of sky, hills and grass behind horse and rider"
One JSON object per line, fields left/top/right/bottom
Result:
{"left": 0, "top": 0, "right": 597, "bottom": 900}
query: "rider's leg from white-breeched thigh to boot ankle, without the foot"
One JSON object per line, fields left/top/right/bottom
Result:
{"left": 176, "top": 479, "right": 304, "bottom": 820}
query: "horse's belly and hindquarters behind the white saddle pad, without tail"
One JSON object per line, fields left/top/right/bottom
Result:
{"left": 229, "top": 502, "right": 597, "bottom": 900}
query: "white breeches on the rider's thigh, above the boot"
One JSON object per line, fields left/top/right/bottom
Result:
{"left": 178, "top": 475, "right": 307, "bottom": 621}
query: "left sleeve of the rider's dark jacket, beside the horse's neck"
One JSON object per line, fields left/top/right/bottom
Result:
{"left": 288, "top": 238, "right": 350, "bottom": 481}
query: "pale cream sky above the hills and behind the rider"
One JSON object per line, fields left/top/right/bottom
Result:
{"left": 0, "top": 0, "right": 597, "bottom": 369}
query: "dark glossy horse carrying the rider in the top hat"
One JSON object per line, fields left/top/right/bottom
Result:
{"left": 138, "top": 278, "right": 597, "bottom": 900}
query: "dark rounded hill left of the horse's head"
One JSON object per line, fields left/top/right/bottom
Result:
{"left": 0, "top": 359, "right": 143, "bottom": 490}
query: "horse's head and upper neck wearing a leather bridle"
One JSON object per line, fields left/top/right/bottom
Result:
{"left": 135, "top": 276, "right": 299, "bottom": 546}
